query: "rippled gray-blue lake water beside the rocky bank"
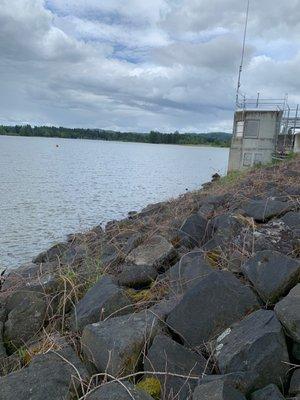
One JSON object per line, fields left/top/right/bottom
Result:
{"left": 0, "top": 136, "right": 228, "bottom": 267}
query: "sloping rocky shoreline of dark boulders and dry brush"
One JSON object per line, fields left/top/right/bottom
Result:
{"left": 0, "top": 158, "right": 300, "bottom": 400}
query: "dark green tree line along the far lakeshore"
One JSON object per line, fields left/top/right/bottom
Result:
{"left": 0, "top": 125, "right": 231, "bottom": 147}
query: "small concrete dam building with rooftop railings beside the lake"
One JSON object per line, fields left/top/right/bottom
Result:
{"left": 228, "top": 95, "right": 300, "bottom": 172}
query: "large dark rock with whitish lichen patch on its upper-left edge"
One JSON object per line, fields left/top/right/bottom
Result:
{"left": 216, "top": 310, "right": 289, "bottom": 389}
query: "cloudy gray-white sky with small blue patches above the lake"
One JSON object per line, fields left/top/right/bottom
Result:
{"left": 0, "top": 0, "right": 300, "bottom": 131}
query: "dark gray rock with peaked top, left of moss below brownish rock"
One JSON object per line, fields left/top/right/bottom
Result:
{"left": 72, "top": 276, "right": 133, "bottom": 330}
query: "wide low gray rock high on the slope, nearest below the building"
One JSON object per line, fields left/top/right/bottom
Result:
{"left": 242, "top": 199, "right": 293, "bottom": 222}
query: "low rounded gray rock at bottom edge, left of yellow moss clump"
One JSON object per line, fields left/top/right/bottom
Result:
{"left": 85, "top": 381, "right": 153, "bottom": 400}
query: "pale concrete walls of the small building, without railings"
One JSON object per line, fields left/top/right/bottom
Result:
{"left": 228, "top": 110, "right": 282, "bottom": 172}
